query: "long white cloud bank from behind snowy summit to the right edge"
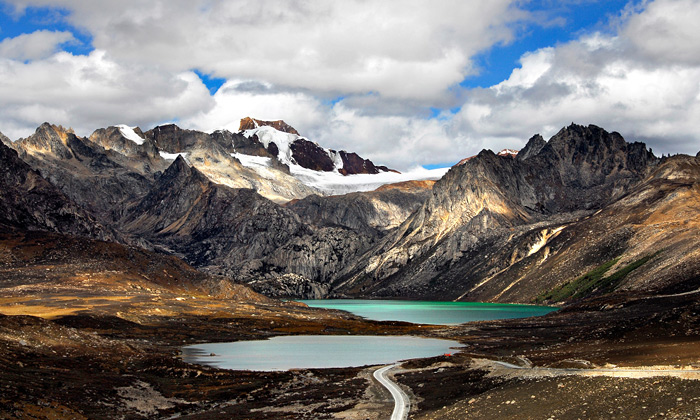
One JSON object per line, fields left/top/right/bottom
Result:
{"left": 175, "top": 0, "right": 700, "bottom": 169}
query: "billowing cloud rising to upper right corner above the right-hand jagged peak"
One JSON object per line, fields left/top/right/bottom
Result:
{"left": 454, "top": 0, "right": 700, "bottom": 154}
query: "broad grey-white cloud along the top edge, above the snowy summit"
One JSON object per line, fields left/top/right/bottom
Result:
{"left": 4, "top": 0, "right": 526, "bottom": 103}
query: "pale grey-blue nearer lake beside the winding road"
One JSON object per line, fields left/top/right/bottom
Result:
{"left": 182, "top": 335, "right": 461, "bottom": 371}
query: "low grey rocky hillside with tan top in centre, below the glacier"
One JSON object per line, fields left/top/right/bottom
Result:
{"left": 219, "top": 182, "right": 433, "bottom": 299}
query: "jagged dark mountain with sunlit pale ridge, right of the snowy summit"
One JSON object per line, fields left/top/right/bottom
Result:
{"left": 338, "top": 125, "right": 658, "bottom": 299}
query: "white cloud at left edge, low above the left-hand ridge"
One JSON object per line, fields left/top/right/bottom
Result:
{"left": 0, "top": 50, "right": 213, "bottom": 139}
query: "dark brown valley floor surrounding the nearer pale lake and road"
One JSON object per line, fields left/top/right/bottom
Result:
{"left": 0, "top": 274, "right": 700, "bottom": 420}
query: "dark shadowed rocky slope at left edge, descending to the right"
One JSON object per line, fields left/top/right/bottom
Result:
{"left": 0, "top": 140, "right": 112, "bottom": 239}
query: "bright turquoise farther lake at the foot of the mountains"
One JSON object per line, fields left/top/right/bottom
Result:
{"left": 299, "top": 299, "right": 558, "bottom": 325}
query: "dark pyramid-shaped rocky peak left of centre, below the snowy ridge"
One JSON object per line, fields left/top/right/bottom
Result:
{"left": 120, "top": 157, "right": 306, "bottom": 267}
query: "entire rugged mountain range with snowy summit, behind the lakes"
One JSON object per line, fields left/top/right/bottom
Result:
{"left": 0, "top": 118, "right": 700, "bottom": 303}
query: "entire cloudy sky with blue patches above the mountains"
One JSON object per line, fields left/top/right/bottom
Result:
{"left": 0, "top": 0, "right": 700, "bottom": 169}
